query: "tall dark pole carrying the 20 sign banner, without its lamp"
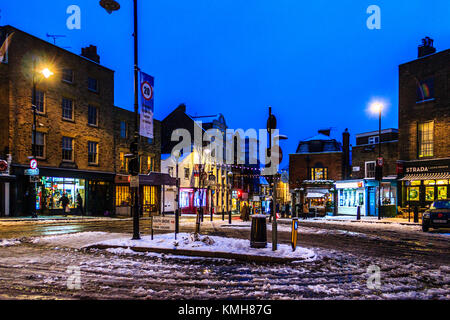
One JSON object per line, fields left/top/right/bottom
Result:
{"left": 132, "top": 0, "right": 141, "bottom": 240}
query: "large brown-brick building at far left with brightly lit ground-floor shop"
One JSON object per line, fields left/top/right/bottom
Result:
{"left": 0, "top": 26, "right": 115, "bottom": 215}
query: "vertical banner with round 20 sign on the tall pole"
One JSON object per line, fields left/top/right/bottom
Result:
{"left": 139, "top": 72, "right": 155, "bottom": 139}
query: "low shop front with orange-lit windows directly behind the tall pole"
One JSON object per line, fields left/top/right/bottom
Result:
{"left": 114, "top": 172, "right": 176, "bottom": 216}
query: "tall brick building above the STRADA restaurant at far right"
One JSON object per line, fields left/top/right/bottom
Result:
{"left": 398, "top": 38, "right": 450, "bottom": 208}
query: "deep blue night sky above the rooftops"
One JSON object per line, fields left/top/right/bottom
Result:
{"left": 0, "top": 0, "right": 450, "bottom": 165}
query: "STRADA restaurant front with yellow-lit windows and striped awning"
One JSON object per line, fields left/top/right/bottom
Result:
{"left": 400, "top": 159, "right": 450, "bottom": 211}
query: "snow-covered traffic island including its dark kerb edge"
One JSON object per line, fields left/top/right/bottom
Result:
{"left": 85, "top": 233, "right": 316, "bottom": 263}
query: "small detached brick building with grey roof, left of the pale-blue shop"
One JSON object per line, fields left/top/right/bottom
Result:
{"left": 289, "top": 130, "right": 350, "bottom": 214}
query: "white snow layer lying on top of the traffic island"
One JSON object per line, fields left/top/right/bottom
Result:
{"left": 92, "top": 233, "right": 316, "bottom": 260}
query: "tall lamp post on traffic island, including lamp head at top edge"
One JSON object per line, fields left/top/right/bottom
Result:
{"left": 100, "top": 0, "right": 141, "bottom": 240}
